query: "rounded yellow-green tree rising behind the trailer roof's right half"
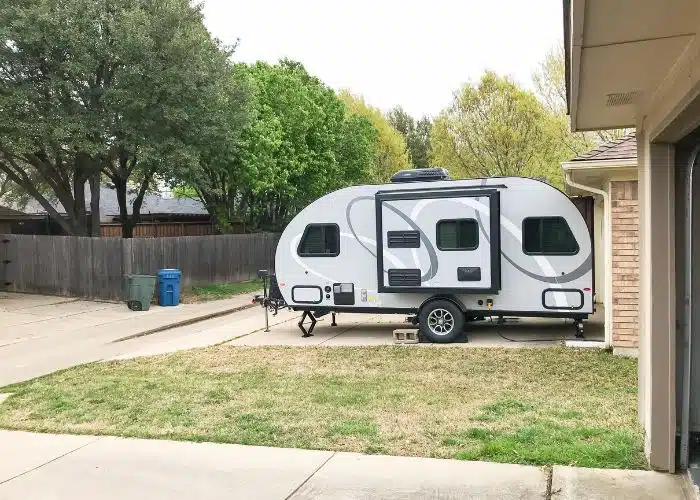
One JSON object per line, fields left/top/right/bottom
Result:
{"left": 432, "top": 72, "right": 561, "bottom": 184}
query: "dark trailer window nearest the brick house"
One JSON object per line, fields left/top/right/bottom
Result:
{"left": 523, "top": 217, "right": 579, "bottom": 255}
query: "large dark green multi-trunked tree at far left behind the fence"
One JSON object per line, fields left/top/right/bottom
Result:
{"left": 0, "top": 0, "right": 238, "bottom": 237}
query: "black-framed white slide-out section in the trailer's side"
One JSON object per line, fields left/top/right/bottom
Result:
{"left": 376, "top": 187, "right": 501, "bottom": 293}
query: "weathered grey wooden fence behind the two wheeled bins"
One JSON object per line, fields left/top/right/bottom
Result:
{"left": 0, "top": 233, "right": 279, "bottom": 300}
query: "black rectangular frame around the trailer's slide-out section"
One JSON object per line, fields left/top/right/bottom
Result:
{"left": 374, "top": 185, "right": 506, "bottom": 294}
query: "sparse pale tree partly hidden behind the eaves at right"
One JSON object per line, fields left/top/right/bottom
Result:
{"left": 532, "top": 43, "right": 630, "bottom": 149}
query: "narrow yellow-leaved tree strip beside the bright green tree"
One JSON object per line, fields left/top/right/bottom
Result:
{"left": 338, "top": 90, "right": 411, "bottom": 183}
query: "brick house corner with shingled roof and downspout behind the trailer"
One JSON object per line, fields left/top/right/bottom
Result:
{"left": 562, "top": 133, "right": 639, "bottom": 356}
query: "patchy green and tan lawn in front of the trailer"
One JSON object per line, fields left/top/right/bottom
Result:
{"left": 0, "top": 345, "right": 646, "bottom": 468}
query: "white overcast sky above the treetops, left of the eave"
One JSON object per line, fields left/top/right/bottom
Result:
{"left": 204, "top": 0, "right": 562, "bottom": 118}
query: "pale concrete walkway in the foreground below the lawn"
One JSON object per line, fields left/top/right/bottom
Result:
{"left": 0, "top": 431, "right": 684, "bottom": 500}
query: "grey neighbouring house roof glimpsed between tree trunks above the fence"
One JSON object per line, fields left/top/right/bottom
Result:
{"left": 24, "top": 185, "right": 207, "bottom": 220}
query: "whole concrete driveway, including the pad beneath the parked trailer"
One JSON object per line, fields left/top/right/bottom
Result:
{"left": 0, "top": 293, "right": 603, "bottom": 387}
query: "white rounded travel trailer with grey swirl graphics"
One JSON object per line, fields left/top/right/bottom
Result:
{"left": 260, "top": 169, "right": 594, "bottom": 342}
